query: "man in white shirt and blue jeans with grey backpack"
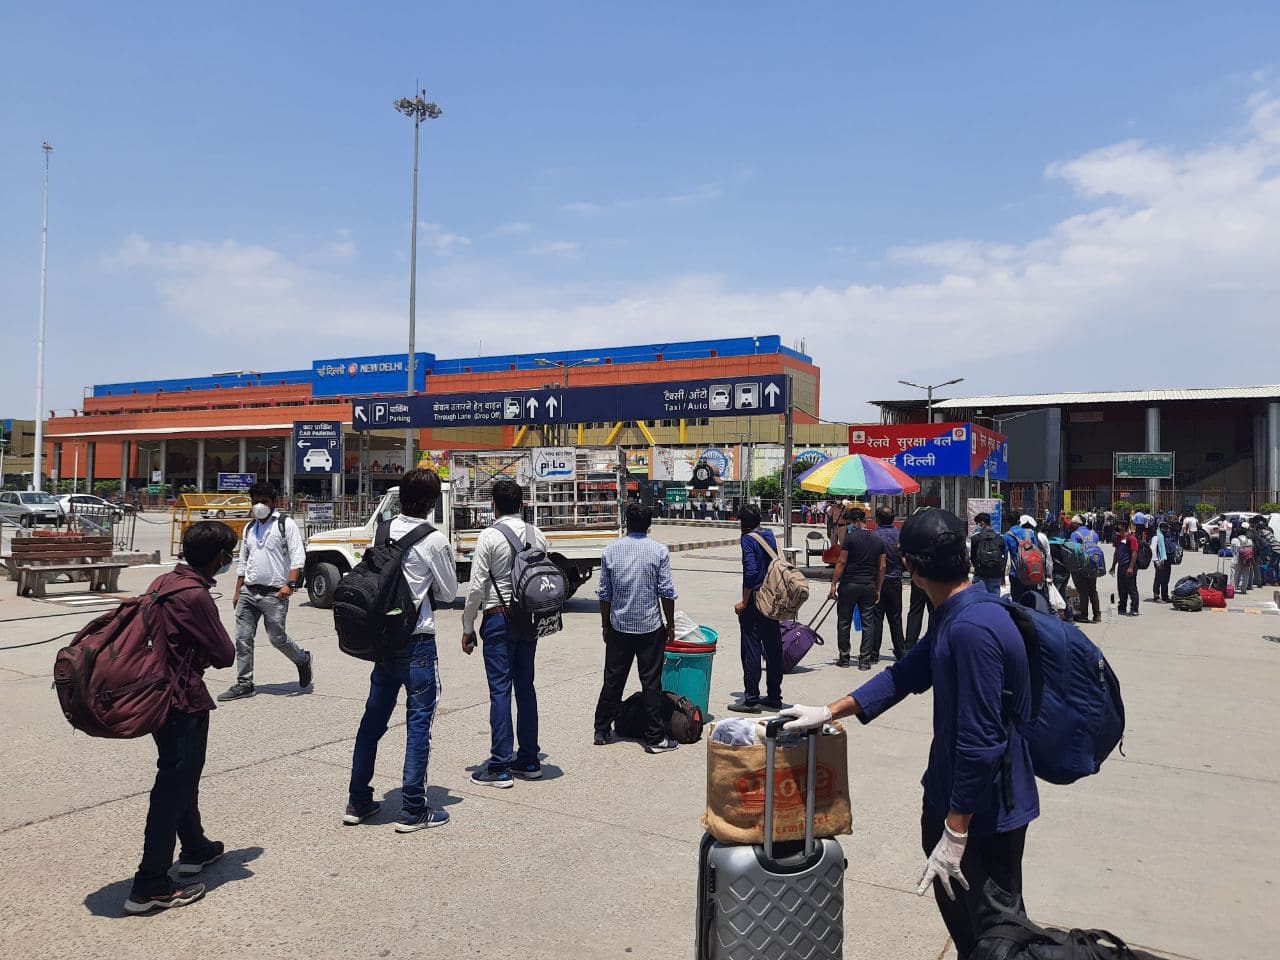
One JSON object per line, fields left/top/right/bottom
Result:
{"left": 462, "top": 480, "right": 547, "bottom": 788}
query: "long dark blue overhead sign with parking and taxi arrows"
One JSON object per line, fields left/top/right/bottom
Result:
{"left": 351, "top": 374, "right": 787, "bottom": 430}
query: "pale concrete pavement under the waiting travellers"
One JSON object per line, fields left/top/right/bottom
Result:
{"left": 0, "top": 537, "right": 1280, "bottom": 960}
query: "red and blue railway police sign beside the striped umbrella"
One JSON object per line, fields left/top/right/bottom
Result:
{"left": 849, "top": 424, "right": 1009, "bottom": 480}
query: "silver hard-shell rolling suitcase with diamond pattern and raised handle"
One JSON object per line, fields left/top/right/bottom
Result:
{"left": 695, "top": 719, "right": 846, "bottom": 960}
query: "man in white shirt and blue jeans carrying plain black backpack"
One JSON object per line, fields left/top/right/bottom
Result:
{"left": 342, "top": 470, "right": 458, "bottom": 833}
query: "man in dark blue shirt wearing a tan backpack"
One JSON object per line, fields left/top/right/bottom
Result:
{"left": 730, "top": 503, "right": 782, "bottom": 713}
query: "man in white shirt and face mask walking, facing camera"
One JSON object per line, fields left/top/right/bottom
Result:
{"left": 218, "top": 484, "right": 311, "bottom": 701}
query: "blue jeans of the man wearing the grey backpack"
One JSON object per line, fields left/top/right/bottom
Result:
{"left": 480, "top": 613, "right": 539, "bottom": 773}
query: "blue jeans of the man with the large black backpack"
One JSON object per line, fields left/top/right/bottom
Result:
{"left": 348, "top": 635, "right": 440, "bottom": 817}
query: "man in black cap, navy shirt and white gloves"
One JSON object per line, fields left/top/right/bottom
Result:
{"left": 782, "top": 509, "right": 1039, "bottom": 960}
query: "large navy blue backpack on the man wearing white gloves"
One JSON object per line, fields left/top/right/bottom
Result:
{"left": 980, "top": 594, "right": 1124, "bottom": 794}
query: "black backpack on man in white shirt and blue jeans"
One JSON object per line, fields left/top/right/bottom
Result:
{"left": 333, "top": 521, "right": 435, "bottom": 663}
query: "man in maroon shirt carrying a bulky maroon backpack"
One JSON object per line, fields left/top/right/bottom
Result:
{"left": 124, "top": 520, "right": 237, "bottom": 914}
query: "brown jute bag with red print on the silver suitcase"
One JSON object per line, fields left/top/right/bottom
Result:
{"left": 703, "top": 721, "right": 852, "bottom": 844}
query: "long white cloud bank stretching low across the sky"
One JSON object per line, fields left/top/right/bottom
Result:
{"left": 94, "top": 95, "right": 1280, "bottom": 419}
